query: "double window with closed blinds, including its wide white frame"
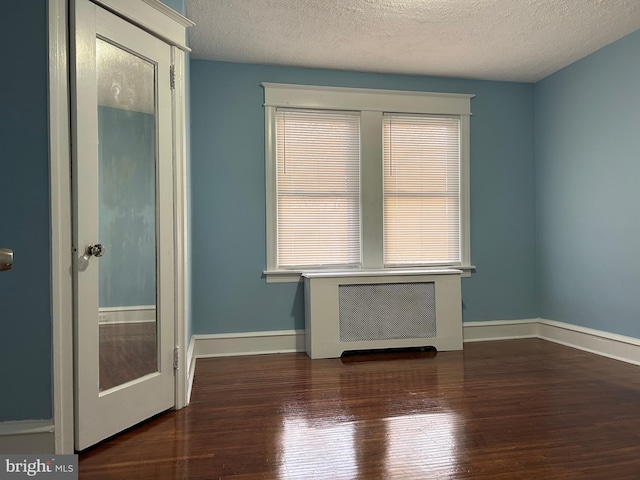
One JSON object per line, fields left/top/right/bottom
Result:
{"left": 263, "top": 83, "right": 473, "bottom": 281}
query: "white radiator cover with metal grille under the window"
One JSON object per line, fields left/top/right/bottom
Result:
{"left": 303, "top": 269, "right": 463, "bottom": 358}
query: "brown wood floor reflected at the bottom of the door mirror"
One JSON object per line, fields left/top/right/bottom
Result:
{"left": 100, "top": 322, "right": 158, "bottom": 390}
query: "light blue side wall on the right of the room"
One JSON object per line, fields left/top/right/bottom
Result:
{"left": 534, "top": 31, "right": 640, "bottom": 337}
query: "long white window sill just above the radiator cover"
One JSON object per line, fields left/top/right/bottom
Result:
{"left": 263, "top": 265, "right": 476, "bottom": 283}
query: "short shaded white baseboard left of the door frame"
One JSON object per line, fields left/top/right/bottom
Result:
{"left": 0, "top": 420, "right": 55, "bottom": 454}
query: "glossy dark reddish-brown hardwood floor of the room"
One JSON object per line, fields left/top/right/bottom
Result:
{"left": 80, "top": 339, "right": 640, "bottom": 480}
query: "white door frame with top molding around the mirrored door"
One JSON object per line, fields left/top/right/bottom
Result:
{"left": 47, "top": 0, "right": 193, "bottom": 454}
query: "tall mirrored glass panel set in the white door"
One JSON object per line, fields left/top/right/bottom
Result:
{"left": 96, "top": 38, "right": 158, "bottom": 391}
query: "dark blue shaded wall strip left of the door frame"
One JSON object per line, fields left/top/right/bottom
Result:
{"left": 0, "top": 0, "right": 52, "bottom": 421}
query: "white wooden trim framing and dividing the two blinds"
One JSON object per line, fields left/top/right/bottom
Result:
{"left": 262, "top": 83, "right": 475, "bottom": 283}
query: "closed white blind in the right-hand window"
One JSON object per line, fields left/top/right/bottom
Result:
{"left": 383, "top": 114, "right": 461, "bottom": 266}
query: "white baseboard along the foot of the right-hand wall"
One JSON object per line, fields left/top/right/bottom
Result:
{"left": 537, "top": 319, "right": 640, "bottom": 365}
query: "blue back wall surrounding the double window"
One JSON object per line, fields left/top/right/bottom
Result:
{"left": 191, "top": 60, "right": 537, "bottom": 333}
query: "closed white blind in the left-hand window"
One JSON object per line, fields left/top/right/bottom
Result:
{"left": 276, "top": 108, "right": 361, "bottom": 268}
